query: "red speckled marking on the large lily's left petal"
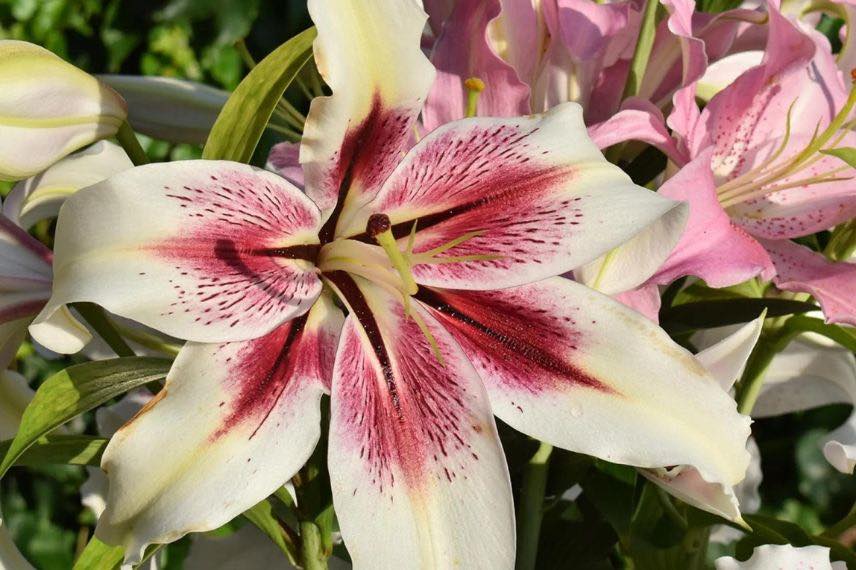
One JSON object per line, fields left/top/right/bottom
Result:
{"left": 152, "top": 171, "right": 321, "bottom": 327}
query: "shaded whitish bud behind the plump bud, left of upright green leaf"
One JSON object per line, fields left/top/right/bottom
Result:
{"left": 99, "top": 75, "right": 229, "bottom": 144}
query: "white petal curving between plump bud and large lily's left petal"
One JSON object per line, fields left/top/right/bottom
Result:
{"left": 3, "top": 141, "right": 134, "bottom": 228}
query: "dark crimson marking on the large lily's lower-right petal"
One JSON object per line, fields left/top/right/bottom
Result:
{"left": 416, "top": 287, "right": 612, "bottom": 395}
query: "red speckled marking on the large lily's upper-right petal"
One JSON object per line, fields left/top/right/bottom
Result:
{"left": 356, "top": 124, "right": 584, "bottom": 279}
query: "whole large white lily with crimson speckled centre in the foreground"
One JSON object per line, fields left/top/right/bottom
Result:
{"left": 34, "top": 0, "right": 749, "bottom": 568}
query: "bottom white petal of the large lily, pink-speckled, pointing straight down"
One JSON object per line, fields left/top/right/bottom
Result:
{"left": 327, "top": 272, "right": 514, "bottom": 568}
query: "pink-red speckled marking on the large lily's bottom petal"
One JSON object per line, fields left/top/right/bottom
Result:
{"left": 329, "top": 272, "right": 485, "bottom": 493}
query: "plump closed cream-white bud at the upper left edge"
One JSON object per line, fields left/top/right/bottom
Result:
{"left": 0, "top": 40, "right": 127, "bottom": 180}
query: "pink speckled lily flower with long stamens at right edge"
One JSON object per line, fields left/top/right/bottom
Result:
{"left": 604, "top": 6, "right": 856, "bottom": 324}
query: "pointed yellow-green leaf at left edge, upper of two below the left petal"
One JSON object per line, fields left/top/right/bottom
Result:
{"left": 0, "top": 357, "right": 170, "bottom": 477}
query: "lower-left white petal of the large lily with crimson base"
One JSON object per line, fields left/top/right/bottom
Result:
{"left": 96, "top": 296, "right": 343, "bottom": 563}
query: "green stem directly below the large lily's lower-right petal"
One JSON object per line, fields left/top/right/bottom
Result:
{"left": 517, "top": 442, "right": 553, "bottom": 570}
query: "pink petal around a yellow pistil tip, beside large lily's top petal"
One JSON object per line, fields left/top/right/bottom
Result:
{"left": 423, "top": 0, "right": 529, "bottom": 131}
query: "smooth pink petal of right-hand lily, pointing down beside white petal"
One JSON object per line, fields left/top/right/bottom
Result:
{"left": 650, "top": 150, "right": 773, "bottom": 287}
